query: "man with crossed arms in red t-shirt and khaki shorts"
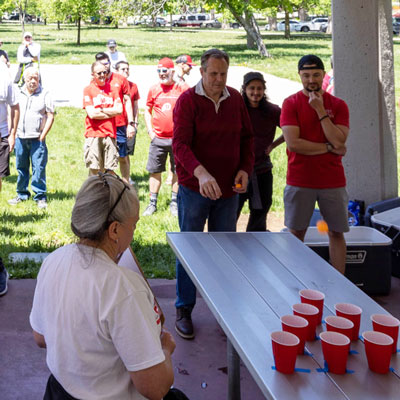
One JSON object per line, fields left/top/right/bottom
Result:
{"left": 83, "top": 61, "right": 122, "bottom": 175}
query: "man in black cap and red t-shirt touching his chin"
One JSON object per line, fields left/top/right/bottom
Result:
{"left": 280, "top": 55, "right": 349, "bottom": 273}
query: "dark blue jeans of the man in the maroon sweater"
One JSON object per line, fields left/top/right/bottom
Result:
{"left": 175, "top": 185, "right": 238, "bottom": 308}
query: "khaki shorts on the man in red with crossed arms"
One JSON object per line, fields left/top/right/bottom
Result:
{"left": 84, "top": 137, "right": 119, "bottom": 170}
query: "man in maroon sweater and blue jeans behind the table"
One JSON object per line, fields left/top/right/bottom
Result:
{"left": 172, "top": 49, "right": 254, "bottom": 339}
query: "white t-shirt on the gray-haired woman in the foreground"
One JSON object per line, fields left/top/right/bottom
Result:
{"left": 30, "top": 244, "right": 165, "bottom": 400}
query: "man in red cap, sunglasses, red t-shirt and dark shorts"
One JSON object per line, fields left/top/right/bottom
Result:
{"left": 143, "top": 57, "right": 189, "bottom": 216}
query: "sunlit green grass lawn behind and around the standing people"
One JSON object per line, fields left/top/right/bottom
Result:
{"left": 0, "top": 24, "right": 400, "bottom": 278}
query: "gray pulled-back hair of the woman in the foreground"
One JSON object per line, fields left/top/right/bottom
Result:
{"left": 71, "top": 173, "right": 139, "bottom": 242}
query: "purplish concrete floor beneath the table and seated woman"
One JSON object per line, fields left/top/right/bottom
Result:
{"left": 0, "top": 277, "right": 400, "bottom": 400}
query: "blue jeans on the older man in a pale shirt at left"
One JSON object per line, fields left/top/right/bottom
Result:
{"left": 15, "top": 138, "right": 47, "bottom": 201}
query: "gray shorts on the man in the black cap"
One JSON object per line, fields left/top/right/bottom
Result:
{"left": 283, "top": 185, "right": 349, "bottom": 232}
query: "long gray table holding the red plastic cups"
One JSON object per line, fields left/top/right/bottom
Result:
{"left": 167, "top": 232, "right": 400, "bottom": 400}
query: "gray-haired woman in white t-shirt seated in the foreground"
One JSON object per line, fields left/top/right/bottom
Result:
{"left": 30, "top": 173, "right": 188, "bottom": 400}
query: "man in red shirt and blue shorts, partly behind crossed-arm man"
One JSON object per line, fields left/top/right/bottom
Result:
{"left": 115, "top": 61, "right": 140, "bottom": 184}
